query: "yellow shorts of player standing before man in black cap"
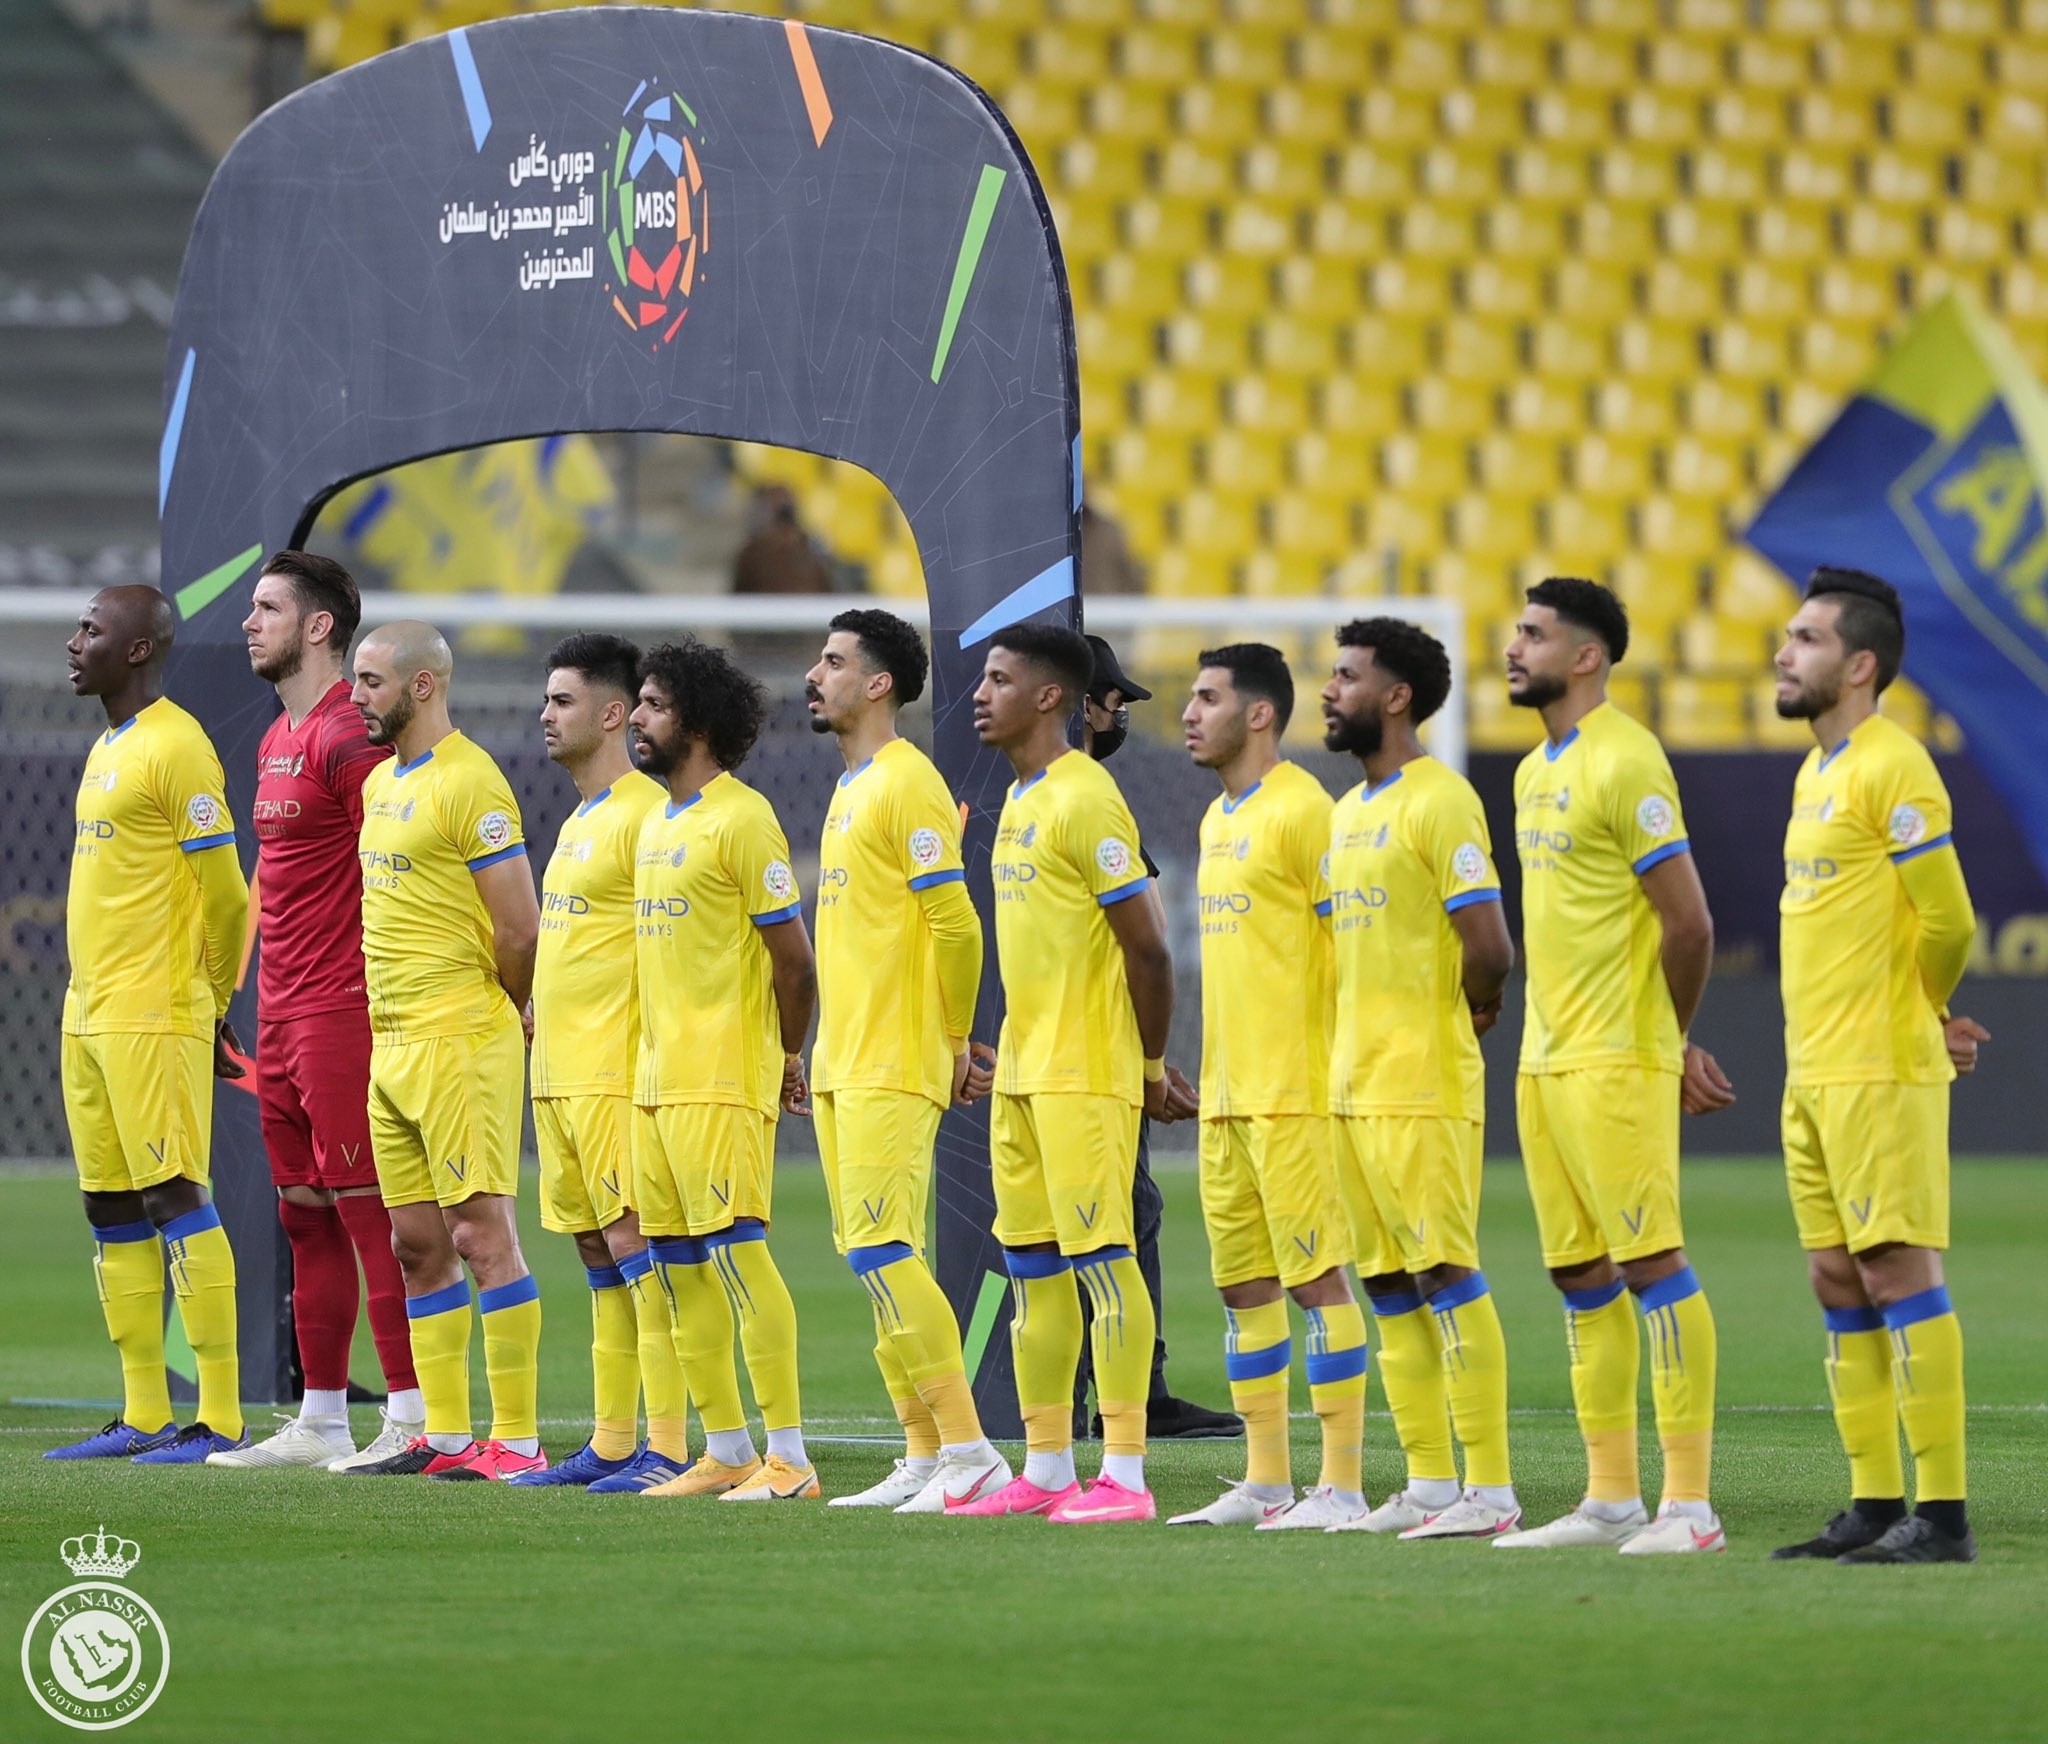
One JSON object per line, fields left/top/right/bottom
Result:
{"left": 989, "top": 1091, "right": 1139, "bottom": 1253}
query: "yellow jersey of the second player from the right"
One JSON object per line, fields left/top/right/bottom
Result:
{"left": 1516, "top": 702, "right": 1690, "bottom": 1073}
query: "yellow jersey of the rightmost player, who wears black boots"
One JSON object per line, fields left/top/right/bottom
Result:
{"left": 1778, "top": 714, "right": 1956, "bottom": 1085}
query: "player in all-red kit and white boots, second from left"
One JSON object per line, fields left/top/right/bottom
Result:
{"left": 207, "top": 551, "right": 426, "bottom": 1470}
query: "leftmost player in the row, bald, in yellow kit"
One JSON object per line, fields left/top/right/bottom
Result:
{"left": 43, "top": 587, "right": 248, "bottom": 1466}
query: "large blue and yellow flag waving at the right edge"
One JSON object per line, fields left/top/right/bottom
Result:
{"left": 1749, "top": 295, "right": 2048, "bottom": 876}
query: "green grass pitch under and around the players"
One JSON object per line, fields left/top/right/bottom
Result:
{"left": 0, "top": 1163, "right": 2048, "bottom": 1744}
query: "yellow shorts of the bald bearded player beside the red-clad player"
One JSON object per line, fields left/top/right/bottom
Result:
{"left": 371, "top": 1023, "right": 526, "bottom": 1206}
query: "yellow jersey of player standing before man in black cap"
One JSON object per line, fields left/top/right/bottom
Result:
{"left": 989, "top": 751, "right": 1151, "bottom": 1107}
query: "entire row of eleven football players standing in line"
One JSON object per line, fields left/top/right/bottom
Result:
{"left": 53, "top": 553, "right": 1987, "bottom": 1562}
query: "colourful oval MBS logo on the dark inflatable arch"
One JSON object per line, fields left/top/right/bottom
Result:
{"left": 604, "top": 80, "right": 711, "bottom": 350}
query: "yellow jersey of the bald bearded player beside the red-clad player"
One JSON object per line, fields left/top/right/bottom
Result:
{"left": 356, "top": 733, "right": 526, "bottom": 1042}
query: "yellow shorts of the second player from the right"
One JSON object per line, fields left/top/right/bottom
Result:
{"left": 1516, "top": 1066, "right": 1686, "bottom": 1267}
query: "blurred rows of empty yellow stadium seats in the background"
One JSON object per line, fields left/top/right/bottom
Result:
{"left": 260, "top": 0, "right": 1982, "bottom": 747}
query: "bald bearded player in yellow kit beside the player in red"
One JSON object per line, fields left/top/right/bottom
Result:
{"left": 348, "top": 620, "right": 547, "bottom": 1480}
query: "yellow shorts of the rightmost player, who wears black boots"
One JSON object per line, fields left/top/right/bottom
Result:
{"left": 1780, "top": 1085, "right": 1948, "bottom": 1253}
